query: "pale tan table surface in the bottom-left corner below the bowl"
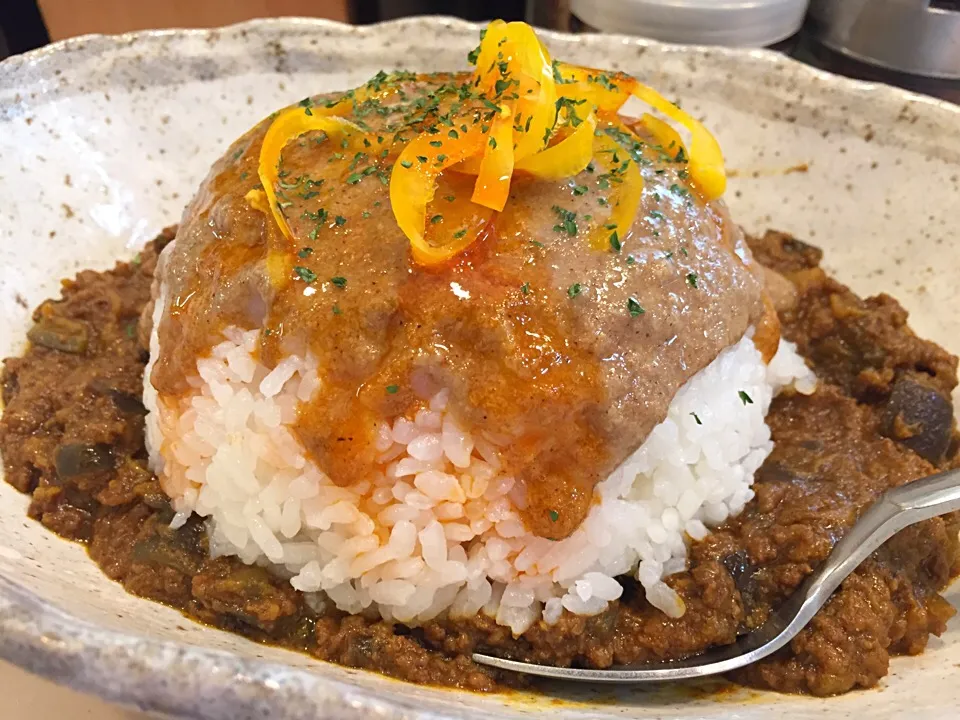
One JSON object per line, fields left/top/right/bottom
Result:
{"left": 0, "top": 662, "right": 149, "bottom": 720}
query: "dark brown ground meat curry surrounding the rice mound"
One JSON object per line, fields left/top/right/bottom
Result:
{"left": 0, "top": 231, "right": 960, "bottom": 695}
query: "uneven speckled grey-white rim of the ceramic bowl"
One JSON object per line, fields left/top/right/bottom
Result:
{"left": 0, "top": 16, "right": 960, "bottom": 720}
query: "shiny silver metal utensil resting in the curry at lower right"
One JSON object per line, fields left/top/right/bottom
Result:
{"left": 473, "top": 469, "right": 960, "bottom": 683}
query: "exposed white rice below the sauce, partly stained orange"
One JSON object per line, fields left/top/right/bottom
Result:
{"left": 144, "top": 320, "right": 816, "bottom": 635}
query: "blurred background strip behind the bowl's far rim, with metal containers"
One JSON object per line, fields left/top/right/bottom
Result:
{"left": 0, "top": 0, "right": 960, "bottom": 102}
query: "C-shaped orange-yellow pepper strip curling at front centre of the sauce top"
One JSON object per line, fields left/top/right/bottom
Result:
{"left": 390, "top": 126, "right": 487, "bottom": 265}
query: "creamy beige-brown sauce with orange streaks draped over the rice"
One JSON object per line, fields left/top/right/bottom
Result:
{"left": 152, "top": 76, "right": 769, "bottom": 538}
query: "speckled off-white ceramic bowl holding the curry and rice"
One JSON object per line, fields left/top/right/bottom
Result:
{"left": 0, "top": 19, "right": 960, "bottom": 720}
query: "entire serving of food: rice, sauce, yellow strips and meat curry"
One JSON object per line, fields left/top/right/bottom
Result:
{"left": 0, "top": 21, "right": 958, "bottom": 695}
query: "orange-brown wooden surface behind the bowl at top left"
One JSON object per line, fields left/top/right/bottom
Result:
{"left": 40, "top": 0, "right": 347, "bottom": 40}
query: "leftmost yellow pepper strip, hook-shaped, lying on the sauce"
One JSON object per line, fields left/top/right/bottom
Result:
{"left": 257, "top": 106, "right": 363, "bottom": 240}
